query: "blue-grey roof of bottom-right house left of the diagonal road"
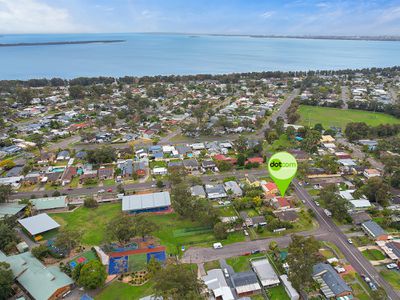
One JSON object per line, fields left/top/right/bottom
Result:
{"left": 313, "top": 263, "right": 351, "bottom": 295}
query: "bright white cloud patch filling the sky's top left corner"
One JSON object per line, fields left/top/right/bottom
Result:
{"left": 0, "top": 0, "right": 87, "bottom": 33}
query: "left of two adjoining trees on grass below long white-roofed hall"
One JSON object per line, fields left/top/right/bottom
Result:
{"left": 106, "top": 214, "right": 135, "bottom": 245}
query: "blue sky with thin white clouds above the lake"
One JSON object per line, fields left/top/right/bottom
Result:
{"left": 0, "top": 0, "right": 400, "bottom": 36}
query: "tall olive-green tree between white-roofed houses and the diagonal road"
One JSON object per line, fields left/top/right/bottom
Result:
{"left": 287, "top": 235, "right": 321, "bottom": 290}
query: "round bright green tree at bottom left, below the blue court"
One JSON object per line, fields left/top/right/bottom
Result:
{"left": 78, "top": 260, "right": 107, "bottom": 290}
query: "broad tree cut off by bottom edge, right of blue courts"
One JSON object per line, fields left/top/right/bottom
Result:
{"left": 154, "top": 264, "right": 204, "bottom": 300}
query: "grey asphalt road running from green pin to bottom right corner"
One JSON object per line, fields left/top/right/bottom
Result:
{"left": 293, "top": 179, "right": 400, "bottom": 300}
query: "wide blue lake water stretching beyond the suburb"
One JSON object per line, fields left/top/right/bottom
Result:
{"left": 0, "top": 34, "right": 400, "bottom": 79}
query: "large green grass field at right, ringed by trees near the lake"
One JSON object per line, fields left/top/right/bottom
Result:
{"left": 298, "top": 105, "right": 400, "bottom": 128}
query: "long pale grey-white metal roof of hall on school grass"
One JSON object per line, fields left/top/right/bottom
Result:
{"left": 122, "top": 192, "right": 171, "bottom": 211}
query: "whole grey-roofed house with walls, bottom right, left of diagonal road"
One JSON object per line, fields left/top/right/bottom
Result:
{"left": 313, "top": 263, "right": 352, "bottom": 299}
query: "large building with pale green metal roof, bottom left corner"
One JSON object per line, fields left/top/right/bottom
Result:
{"left": 0, "top": 251, "right": 74, "bottom": 300}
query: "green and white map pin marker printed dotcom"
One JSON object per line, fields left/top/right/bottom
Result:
{"left": 268, "top": 152, "right": 297, "bottom": 197}
